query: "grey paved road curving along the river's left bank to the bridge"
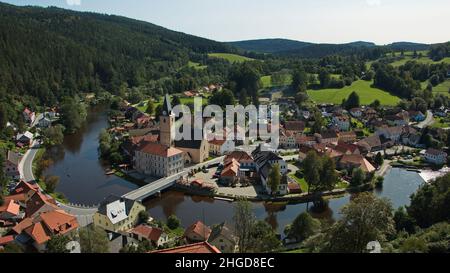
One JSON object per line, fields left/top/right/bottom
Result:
{"left": 19, "top": 141, "right": 97, "bottom": 227}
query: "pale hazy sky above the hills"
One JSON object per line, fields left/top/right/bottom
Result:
{"left": 0, "top": 0, "right": 450, "bottom": 45}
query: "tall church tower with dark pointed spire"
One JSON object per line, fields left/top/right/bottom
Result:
{"left": 159, "top": 94, "right": 175, "bottom": 147}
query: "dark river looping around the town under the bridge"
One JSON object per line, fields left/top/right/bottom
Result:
{"left": 45, "top": 107, "right": 424, "bottom": 233}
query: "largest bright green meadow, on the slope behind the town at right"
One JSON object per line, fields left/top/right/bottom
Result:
{"left": 307, "top": 80, "right": 400, "bottom": 105}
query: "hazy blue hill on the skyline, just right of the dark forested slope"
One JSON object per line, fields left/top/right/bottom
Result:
{"left": 227, "top": 39, "right": 312, "bottom": 53}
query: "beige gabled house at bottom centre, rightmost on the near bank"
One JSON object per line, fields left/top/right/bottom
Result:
{"left": 208, "top": 223, "right": 238, "bottom": 253}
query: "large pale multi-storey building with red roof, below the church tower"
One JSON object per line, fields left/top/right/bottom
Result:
{"left": 134, "top": 142, "right": 184, "bottom": 177}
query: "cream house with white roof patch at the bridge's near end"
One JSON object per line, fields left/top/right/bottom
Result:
{"left": 93, "top": 195, "right": 145, "bottom": 232}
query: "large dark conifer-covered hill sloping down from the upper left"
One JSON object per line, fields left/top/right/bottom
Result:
{"left": 0, "top": 3, "right": 233, "bottom": 104}
